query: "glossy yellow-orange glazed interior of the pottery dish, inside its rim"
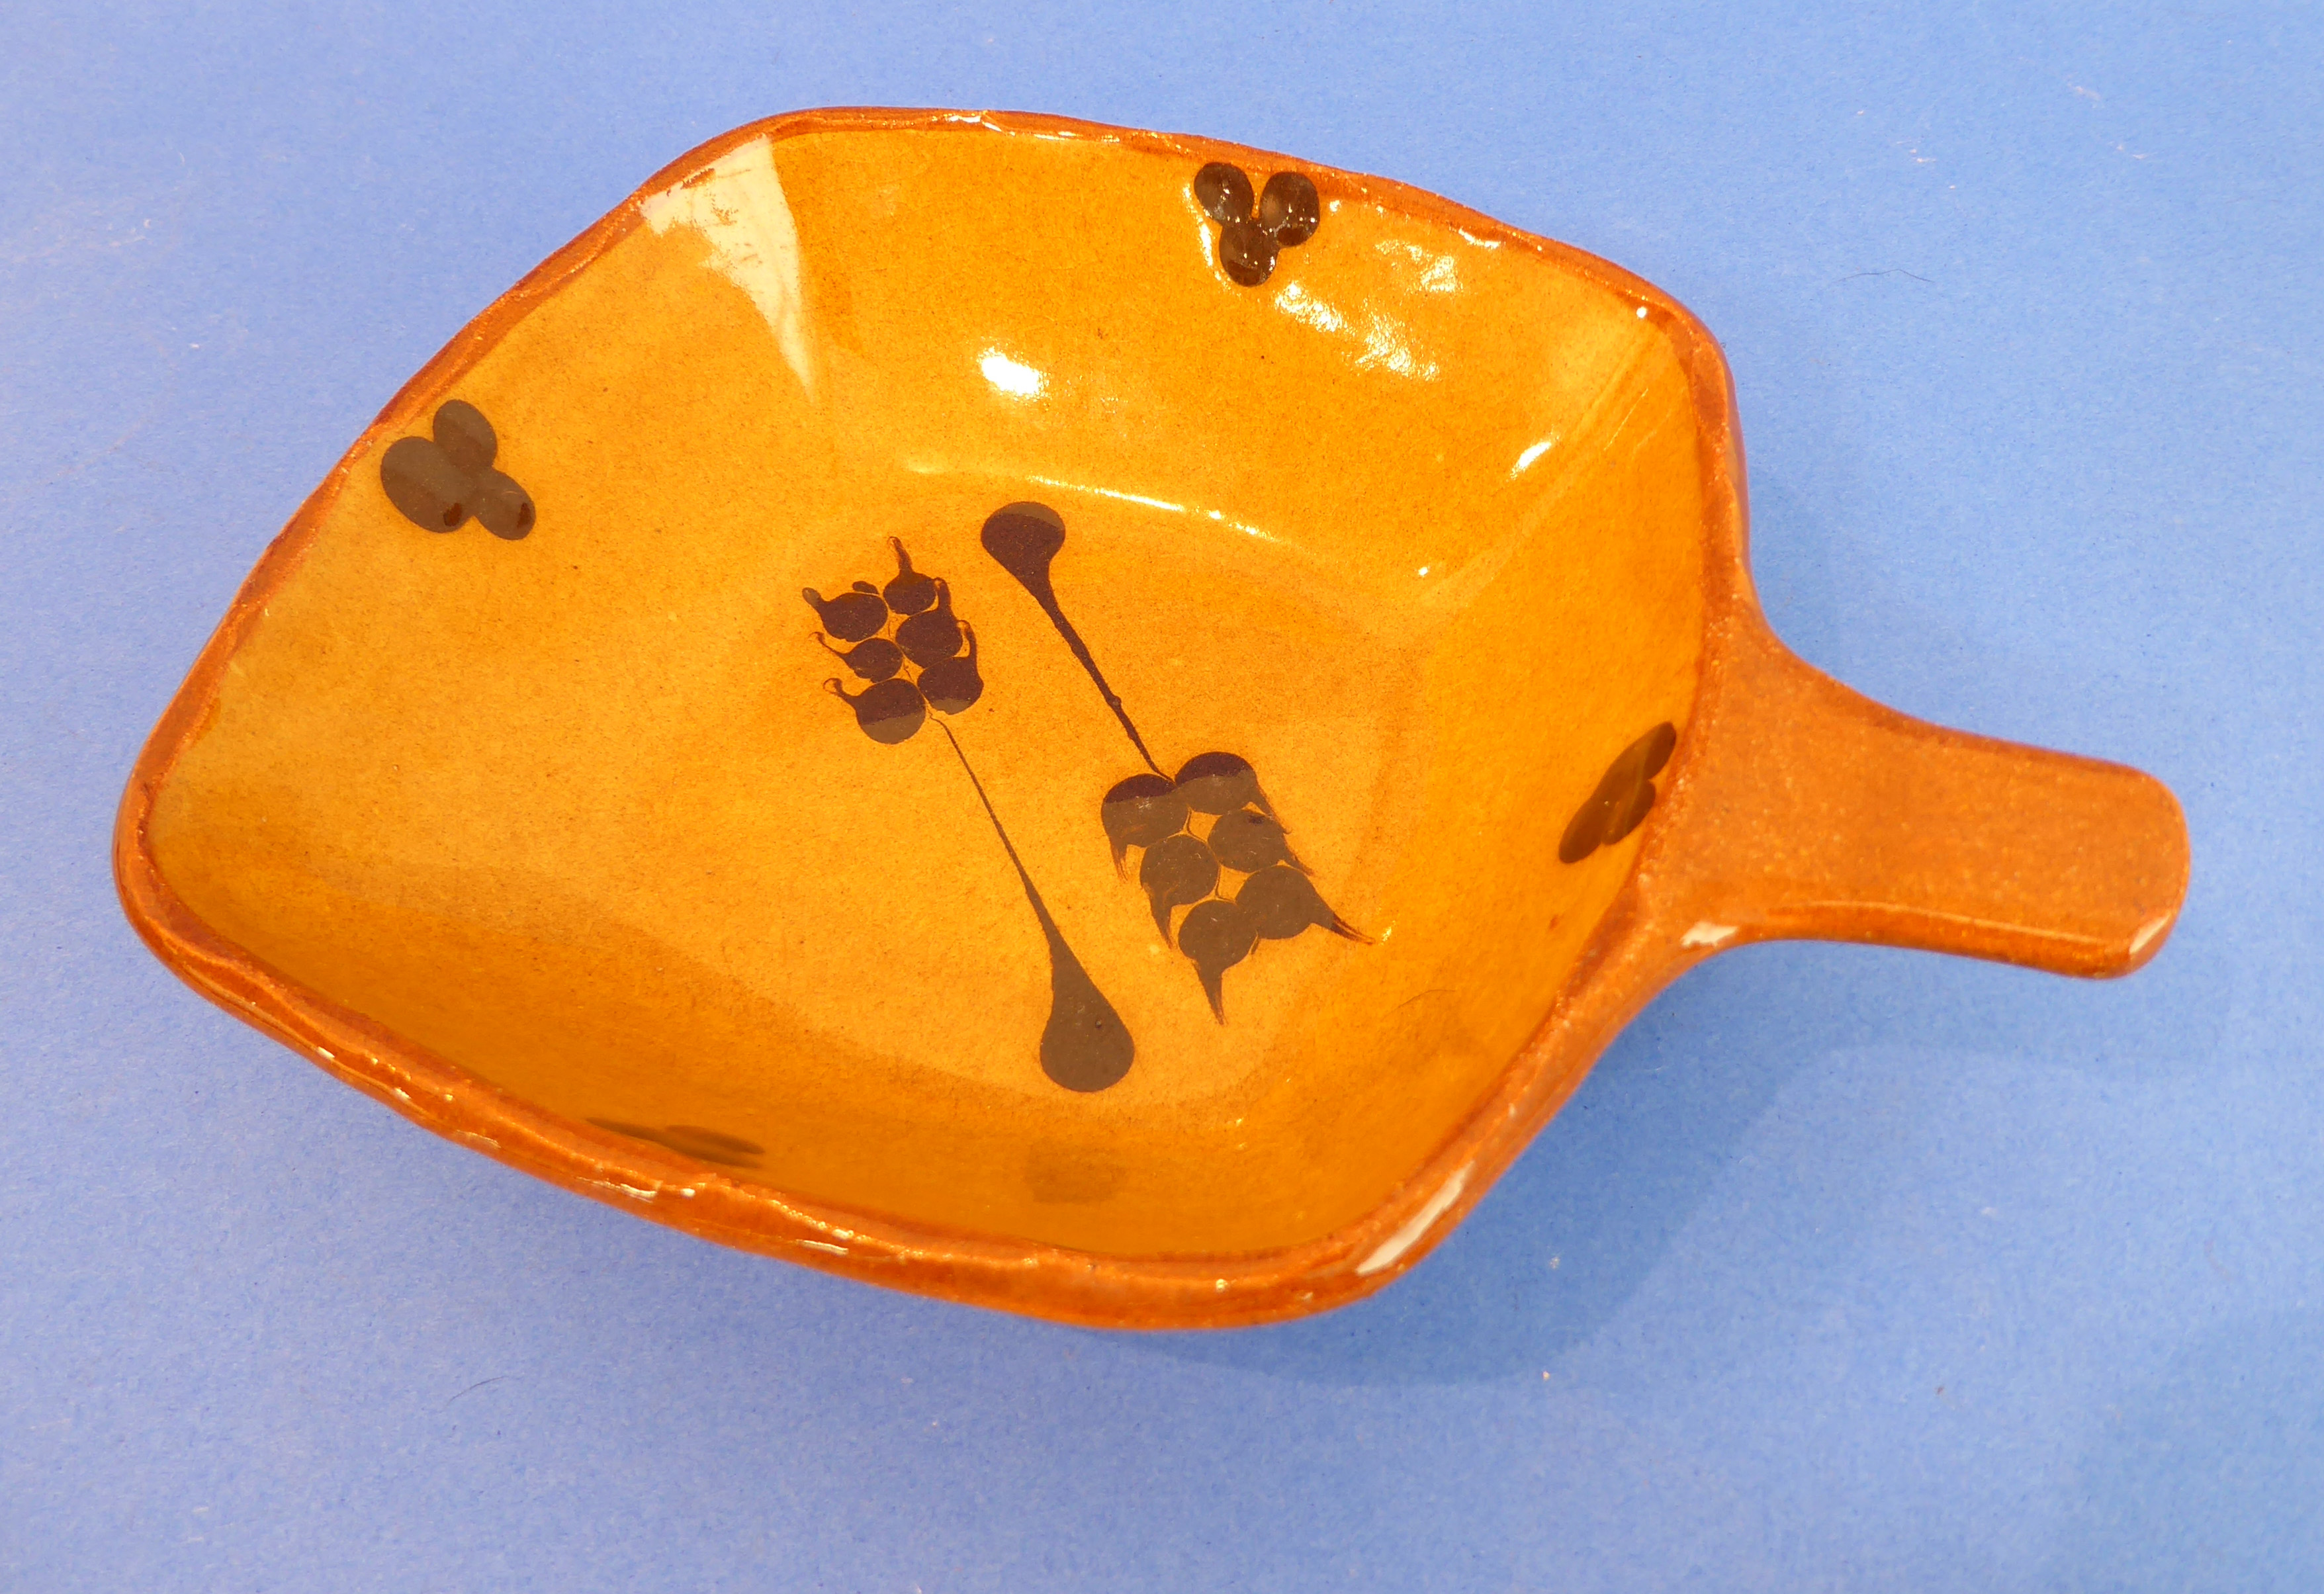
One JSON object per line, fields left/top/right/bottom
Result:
{"left": 149, "top": 123, "right": 1703, "bottom": 1255}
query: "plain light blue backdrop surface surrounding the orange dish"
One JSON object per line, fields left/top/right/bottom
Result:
{"left": 0, "top": 0, "right": 2324, "bottom": 1594}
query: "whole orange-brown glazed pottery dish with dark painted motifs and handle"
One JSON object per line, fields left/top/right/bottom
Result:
{"left": 114, "top": 112, "right": 2187, "bottom": 1327}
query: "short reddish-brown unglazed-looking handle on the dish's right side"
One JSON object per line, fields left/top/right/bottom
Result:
{"left": 1671, "top": 623, "right": 2187, "bottom": 976}
